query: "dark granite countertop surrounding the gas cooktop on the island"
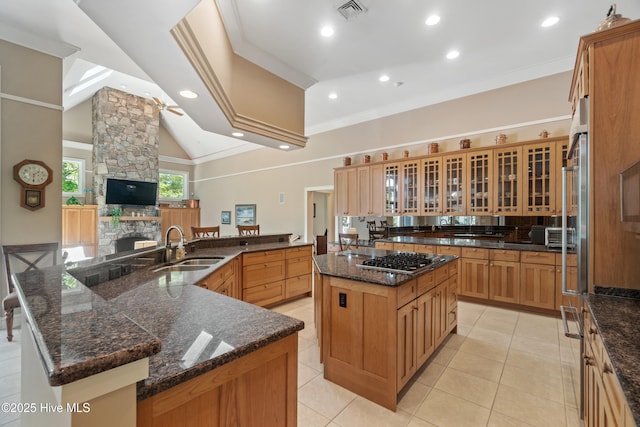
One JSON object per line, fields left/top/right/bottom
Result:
{"left": 313, "top": 248, "right": 458, "bottom": 286}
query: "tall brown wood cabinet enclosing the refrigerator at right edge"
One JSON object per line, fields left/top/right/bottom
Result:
{"left": 569, "top": 20, "right": 640, "bottom": 290}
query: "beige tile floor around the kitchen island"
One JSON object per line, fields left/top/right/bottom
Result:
{"left": 0, "top": 298, "right": 582, "bottom": 427}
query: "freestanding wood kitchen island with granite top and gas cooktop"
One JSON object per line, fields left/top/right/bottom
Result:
{"left": 314, "top": 248, "right": 458, "bottom": 411}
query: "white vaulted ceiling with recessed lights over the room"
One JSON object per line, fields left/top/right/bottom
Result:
{"left": 0, "top": 0, "right": 640, "bottom": 162}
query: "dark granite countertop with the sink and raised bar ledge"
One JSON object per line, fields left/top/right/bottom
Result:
{"left": 16, "top": 241, "right": 311, "bottom": 399}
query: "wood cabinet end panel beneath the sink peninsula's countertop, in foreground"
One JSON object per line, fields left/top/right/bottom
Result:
{"left": 136, "top": 334, "right": 298, "bottom": 427}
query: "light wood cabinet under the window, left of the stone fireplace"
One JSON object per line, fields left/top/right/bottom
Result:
{"left": 62, "top": 205, "right": 98, "bottom": 257}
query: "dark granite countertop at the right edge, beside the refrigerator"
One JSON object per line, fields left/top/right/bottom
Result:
{"left": 588, "top": 287, "right": 640, "bottom": 426}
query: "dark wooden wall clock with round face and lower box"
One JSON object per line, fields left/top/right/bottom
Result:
{"left": 13, "top": 159, "right": 53, "bottom": 211}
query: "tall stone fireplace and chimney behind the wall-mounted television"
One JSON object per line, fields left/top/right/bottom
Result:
{"left": 92, "top": 87, "right": 161, "bottom": 255}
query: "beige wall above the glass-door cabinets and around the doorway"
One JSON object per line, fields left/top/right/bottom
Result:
{"left": 194, "top": 71, "right": 572, "bottom": 241}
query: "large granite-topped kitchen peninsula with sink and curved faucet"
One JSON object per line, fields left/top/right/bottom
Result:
{"left": 11, "top": 235, "right": 310, "bottom": 426}
